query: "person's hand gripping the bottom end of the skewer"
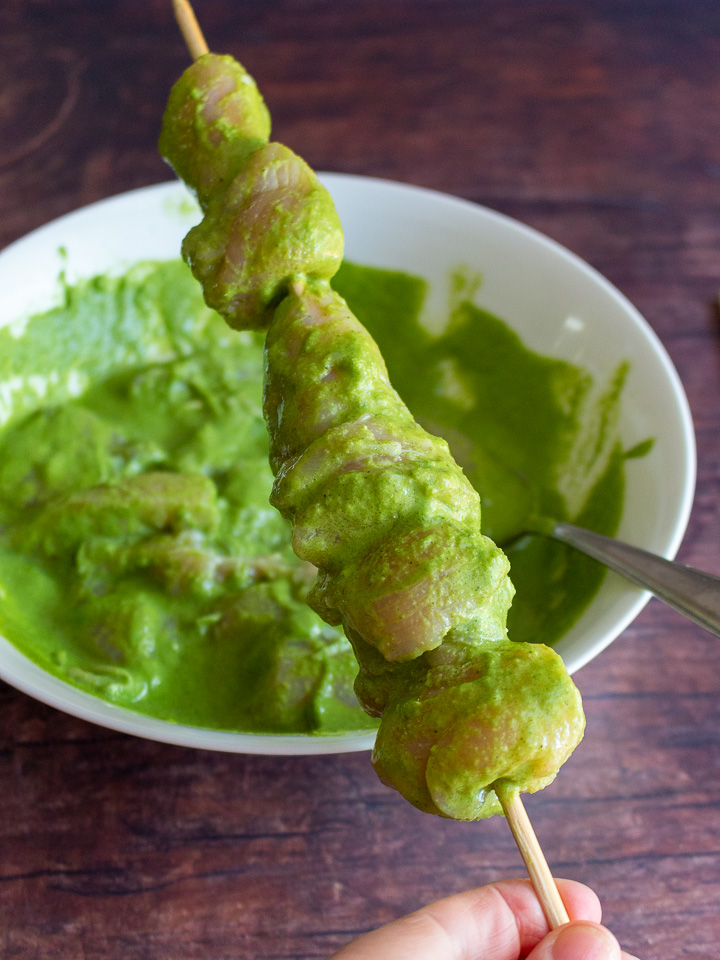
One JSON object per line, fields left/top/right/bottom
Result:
{"left": 330, "top": 880, "right": 636, "bottom": 960}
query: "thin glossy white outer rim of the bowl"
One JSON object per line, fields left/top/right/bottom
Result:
{"left": 0, "top": 173, "right": 697, "bottom": 756}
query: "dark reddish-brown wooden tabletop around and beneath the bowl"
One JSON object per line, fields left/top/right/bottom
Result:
{"left": 0, "top": 0, "right": 720, "bottom": 960}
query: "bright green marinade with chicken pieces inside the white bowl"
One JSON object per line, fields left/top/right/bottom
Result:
{"left": 0, "top": 262, "right": 623, "bottom": 733}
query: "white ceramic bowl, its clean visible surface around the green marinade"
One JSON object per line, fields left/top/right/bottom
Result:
{"left": 0, "top": 174, "right": 696, "bottom": 754}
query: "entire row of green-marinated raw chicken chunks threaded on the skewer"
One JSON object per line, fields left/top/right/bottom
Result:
{"left": 161, "top": 54, "right": 584, "bottom": 820}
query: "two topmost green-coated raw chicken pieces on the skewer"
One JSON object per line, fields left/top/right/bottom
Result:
{"left": 160, "top": 54, "right": 343, "bottom": 330}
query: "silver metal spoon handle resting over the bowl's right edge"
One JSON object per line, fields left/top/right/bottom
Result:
{"left": 548, "top": 523, "right": 720, "bottom": 637}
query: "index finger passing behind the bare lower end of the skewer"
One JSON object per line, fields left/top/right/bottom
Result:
{"left": 333, "top": 880, "right": 600, "bottom": 960}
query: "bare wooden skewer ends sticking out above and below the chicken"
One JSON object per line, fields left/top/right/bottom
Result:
{"left": 173, "top": 0, "right": 570, "bottom": 930}
